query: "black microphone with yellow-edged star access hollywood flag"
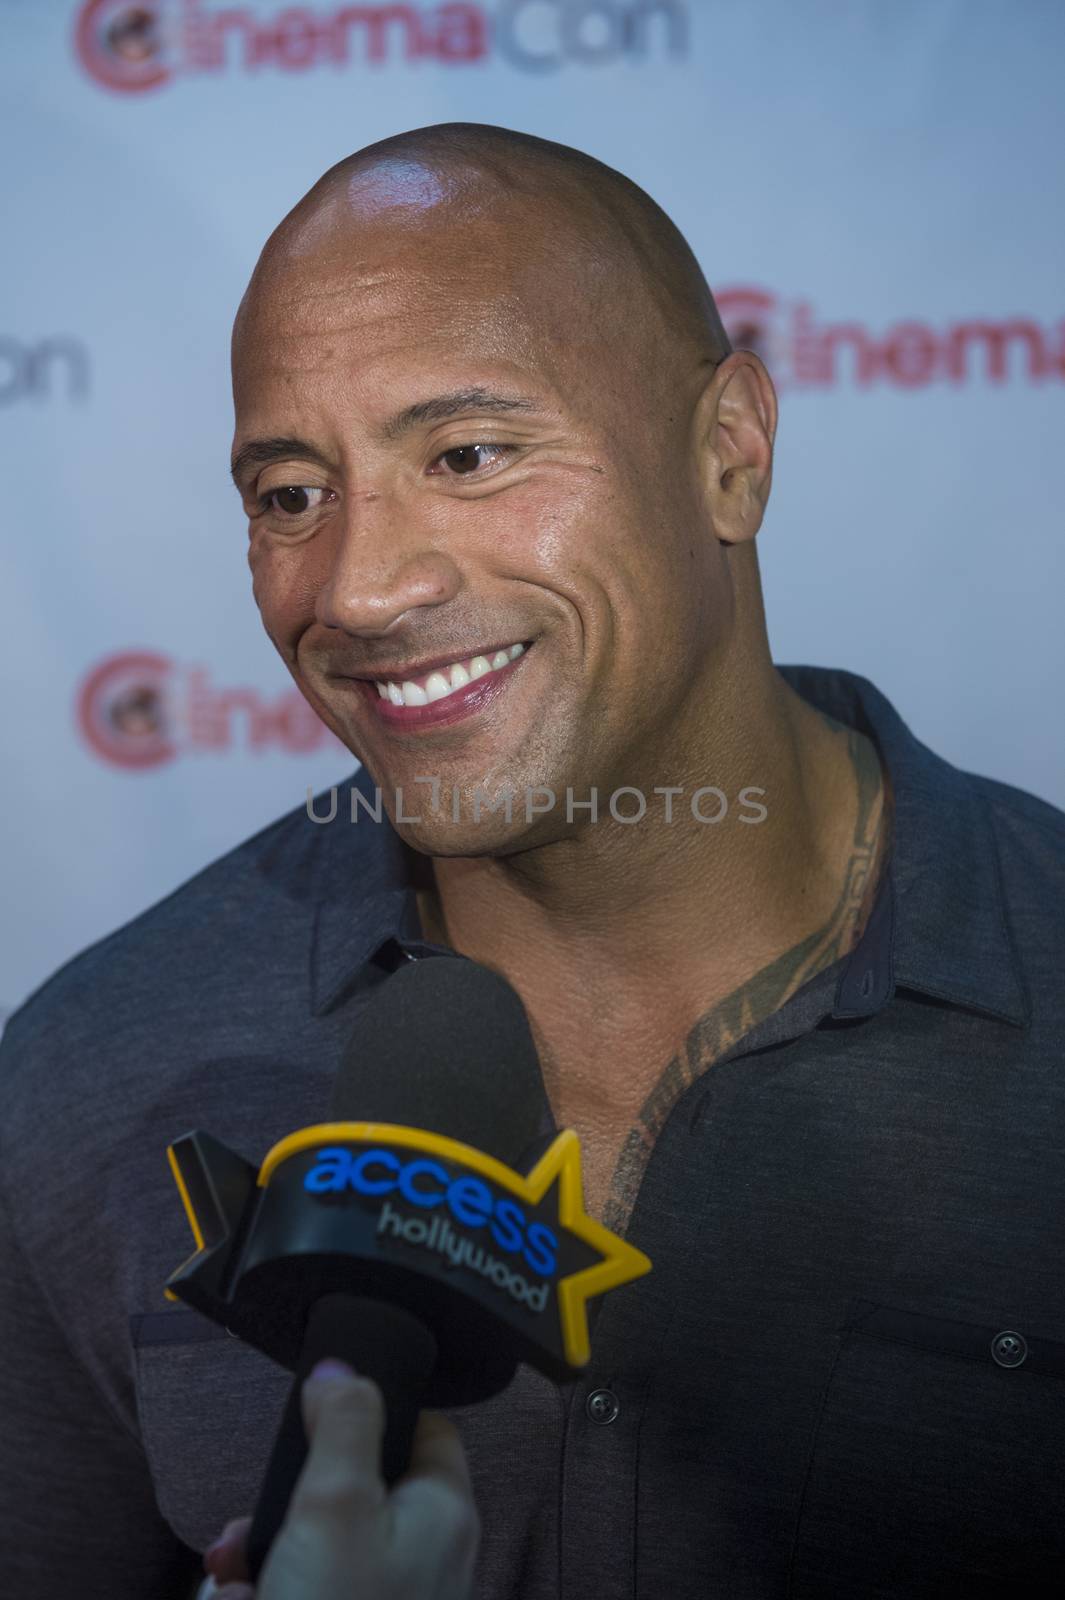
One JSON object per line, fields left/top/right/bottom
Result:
{"left": 165, "top": 957, "right": 651, "bottom": 1582}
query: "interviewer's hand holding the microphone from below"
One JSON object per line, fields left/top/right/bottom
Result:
{"left": 203, "top": 1363, "right": 480, "bottom": 1600}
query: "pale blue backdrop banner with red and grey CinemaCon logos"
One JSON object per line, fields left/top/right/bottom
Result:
{"left": 0, "top": 0, "right": 1065, "bottom": 1014}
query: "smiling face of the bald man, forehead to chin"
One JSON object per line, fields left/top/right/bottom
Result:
{"left": 233, "top": 162, "right": 732, "bottom": 856}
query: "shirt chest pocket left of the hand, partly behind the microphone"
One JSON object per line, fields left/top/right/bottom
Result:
{"left": 130, "top": 1309, "right": 293, "bottom": 1550}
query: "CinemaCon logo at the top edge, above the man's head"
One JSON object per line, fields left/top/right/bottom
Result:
{"left": 74, "top": 0, "right": 688, "bottom": 94}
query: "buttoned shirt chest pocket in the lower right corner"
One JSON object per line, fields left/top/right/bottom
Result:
{"left": 787, "top": 1301, "right": 1065, "bottom": 1600}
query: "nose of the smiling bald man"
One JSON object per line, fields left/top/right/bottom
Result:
{"left": 315, "top": 490, "right": 461, "bottom": 635}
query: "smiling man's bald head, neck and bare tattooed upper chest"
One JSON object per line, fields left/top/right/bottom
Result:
{"left": 233, "top": 125, "right": 889, "bottom": 1230}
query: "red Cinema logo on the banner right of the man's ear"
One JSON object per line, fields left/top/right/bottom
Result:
{"left": 715, "top": 286, "right": 1065, "bottom": 390}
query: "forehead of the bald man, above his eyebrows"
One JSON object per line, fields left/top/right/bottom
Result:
{"left": 233, "top": 183, "right": 609, "bottom": 408}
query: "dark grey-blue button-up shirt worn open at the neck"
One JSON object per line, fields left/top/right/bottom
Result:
{"left": 0, "top": 667, "right": 1065, "bottom": 1600}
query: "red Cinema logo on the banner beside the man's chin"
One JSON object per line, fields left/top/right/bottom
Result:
{"left": 75, "top": 650, "right": 343, "bottom": 770}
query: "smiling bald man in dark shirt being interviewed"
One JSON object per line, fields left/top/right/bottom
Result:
{"left": 0, "top": 123, "right": 1065, "bottom": 1600}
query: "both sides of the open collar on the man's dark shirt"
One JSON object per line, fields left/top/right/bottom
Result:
{"left": 309, "top": 666, "right": 1030, "bottom": 1027}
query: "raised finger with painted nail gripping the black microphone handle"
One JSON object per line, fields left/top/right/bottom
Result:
{"left": 289, "top": 1376, "right": 387, "bottom": 1523}
